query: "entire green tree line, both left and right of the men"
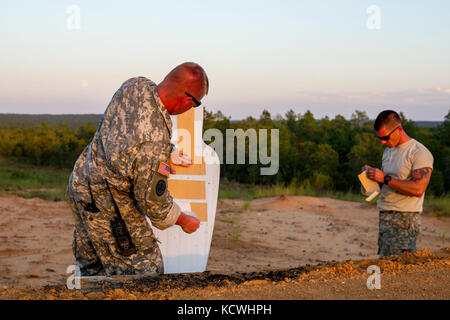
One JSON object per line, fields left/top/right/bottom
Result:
{"left": 0, "top": 110, "right": 450, "bottom": 195}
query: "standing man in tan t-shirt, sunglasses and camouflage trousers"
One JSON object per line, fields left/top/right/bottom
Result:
{"left": 363, "top": 110, "right": 433, "bottom": 257}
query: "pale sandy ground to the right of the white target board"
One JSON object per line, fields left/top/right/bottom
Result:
{"left": 208, "top": 196, "right": 450, "bottom": 272}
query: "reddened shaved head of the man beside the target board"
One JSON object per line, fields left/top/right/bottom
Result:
{"left": 158, "top": 62, "right": 209, "bottom": 114}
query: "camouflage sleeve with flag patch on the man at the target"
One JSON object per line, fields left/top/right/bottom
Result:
{"left": 132, "top": 142, "right": 181, "bottom": 230}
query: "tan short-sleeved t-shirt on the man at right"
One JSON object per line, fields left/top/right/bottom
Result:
{"left": 377, "top": 139, "right": 434, "bottom": 212}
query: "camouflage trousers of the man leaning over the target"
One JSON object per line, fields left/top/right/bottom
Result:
{"left": 69, "top": 192, "right": 164, "bottom": 276}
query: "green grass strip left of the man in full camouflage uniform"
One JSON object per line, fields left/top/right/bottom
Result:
{"left": 0, "top": 159, "right": 70, "bottom": 201}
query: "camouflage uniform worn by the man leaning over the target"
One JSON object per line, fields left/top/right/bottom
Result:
{"left": 68, "top": 77, "right": 180, "bottom": 276}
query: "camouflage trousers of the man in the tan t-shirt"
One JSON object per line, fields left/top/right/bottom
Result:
{"left": 378, "top": 211, "right": 420, "bottom": 258}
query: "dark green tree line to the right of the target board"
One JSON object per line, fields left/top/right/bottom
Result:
{"left": 204, "top": 110, "right": 450, "bottom": 195}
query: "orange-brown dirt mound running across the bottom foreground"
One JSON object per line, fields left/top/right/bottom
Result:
{"left": 0, "top": 248, "right": 450, "bottom": 300}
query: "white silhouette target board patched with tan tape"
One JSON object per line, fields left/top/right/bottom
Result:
{"left": 147, "top": 106, "right": 220, "bottom": 273}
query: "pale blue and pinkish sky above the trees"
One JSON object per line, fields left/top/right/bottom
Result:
{"left": 0, "top": 0, "right": 450, "bottom": 121}
